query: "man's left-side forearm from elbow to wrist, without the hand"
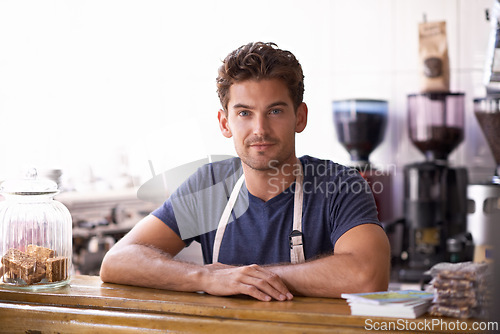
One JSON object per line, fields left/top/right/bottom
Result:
{"left": 100, "top": 244, "right": 204, "bottom": 291}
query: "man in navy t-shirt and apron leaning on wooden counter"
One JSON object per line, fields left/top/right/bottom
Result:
{"left": 101, "top": 42, "right": 390, "bottom": 301}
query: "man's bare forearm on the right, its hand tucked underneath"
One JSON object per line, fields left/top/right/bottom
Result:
{"left": 268, "top": 250, "right": 390, "bottom": 298}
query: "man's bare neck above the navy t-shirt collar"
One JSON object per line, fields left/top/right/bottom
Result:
{"left": 243, "top": 155, "right": 300, "bottom": 202}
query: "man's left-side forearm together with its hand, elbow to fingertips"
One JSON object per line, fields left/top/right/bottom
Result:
{"left": 101, "top": 244, "right": 293, "bottom": 301}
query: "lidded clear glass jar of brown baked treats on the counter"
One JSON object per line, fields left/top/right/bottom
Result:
{"left": 0, "top": 170, "right": 72, "bottom": 290}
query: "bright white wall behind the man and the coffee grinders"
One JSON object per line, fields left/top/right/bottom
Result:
{"left": 0, "top": 0, "right": 493, "bottom": 219}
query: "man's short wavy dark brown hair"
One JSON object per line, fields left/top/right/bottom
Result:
{"left": 217, "top": 42, "right": 304, "bottom": 112}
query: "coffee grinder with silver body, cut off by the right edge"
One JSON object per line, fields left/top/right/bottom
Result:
{"left": 467, "top": 95, "right": 500, "bottom": 262}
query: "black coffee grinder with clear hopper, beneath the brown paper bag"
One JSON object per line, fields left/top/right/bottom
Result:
{"left": 399, "top": 92, "right": 470, "bottom": 281}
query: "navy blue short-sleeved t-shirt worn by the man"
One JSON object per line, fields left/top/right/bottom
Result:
{"left": 152, "top": 156, "right": 380, "bottom": 265}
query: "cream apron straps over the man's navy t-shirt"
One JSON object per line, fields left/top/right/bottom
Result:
{"left": 212, "top": 161, "right": 305, "bottom": 264}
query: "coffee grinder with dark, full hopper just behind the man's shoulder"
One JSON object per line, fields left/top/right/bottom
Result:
{"left": 333, "top": 99, "right": 392, "bottom": 222}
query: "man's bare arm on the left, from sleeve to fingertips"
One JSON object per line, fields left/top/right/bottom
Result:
{"left": 100, "top": 215, "right": 292, "bottom": 300}
